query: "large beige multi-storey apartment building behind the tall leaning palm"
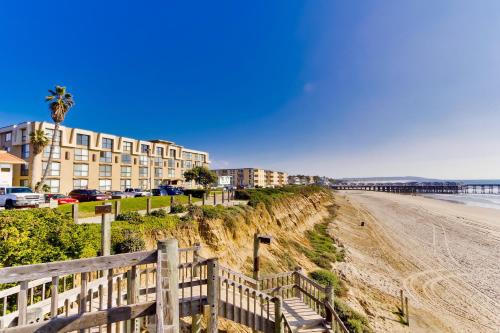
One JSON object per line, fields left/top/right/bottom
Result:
{"left": 0, "top": 121, "right": 210, "bottom": 193}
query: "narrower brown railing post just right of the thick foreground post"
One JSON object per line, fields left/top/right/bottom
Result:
{"left": 207, "top": 258, "right": 220, "bottom": 333}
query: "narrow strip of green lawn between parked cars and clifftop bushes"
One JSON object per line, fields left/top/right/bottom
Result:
{"left": 58, "top": 195, "right": 200, "bottom": 218}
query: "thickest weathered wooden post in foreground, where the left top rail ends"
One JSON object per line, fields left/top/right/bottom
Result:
{"left": 156, "top": 239, "right": 179, "bottom": 333}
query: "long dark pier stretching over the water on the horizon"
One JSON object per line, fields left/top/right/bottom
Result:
{"left": 330, "top": 182, "right": 500, "bottom": 195}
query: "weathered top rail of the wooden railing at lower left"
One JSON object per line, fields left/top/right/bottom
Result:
{"left": 0, "top": 250, "right": 156, "bottom": 283}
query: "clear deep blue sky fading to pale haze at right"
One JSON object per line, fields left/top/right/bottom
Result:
{"left": 0, "top": 0, "right": 500, "bottom": 178}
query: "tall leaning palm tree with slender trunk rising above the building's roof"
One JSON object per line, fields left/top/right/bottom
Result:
{"left": 35, "top": 86, "right": 75, "bottom": 191}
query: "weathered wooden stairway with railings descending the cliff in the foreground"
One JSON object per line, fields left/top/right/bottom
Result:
{"left": 0, "top": 239, "right": 348, "bottom": 333}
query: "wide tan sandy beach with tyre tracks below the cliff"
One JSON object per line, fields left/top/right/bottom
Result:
{"left": 331, "top": 192, "right": 500, "bottom": 332}
